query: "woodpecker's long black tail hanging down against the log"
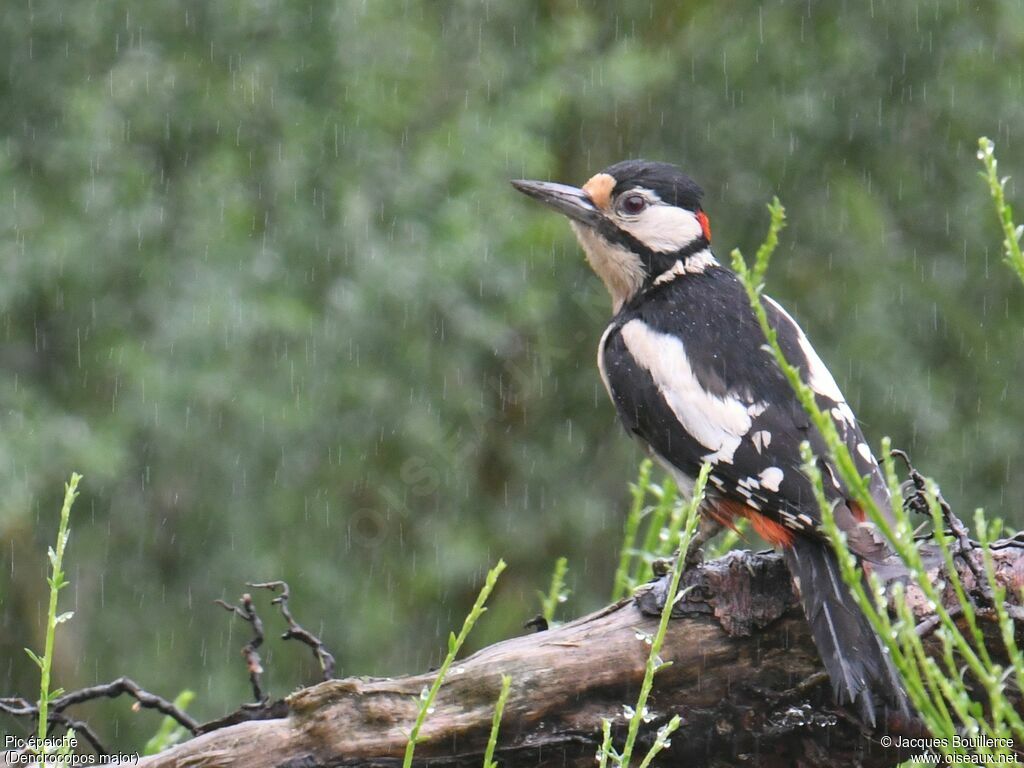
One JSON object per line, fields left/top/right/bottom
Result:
{"left": 783, "top": 537, "right": 908, "bottom": 726}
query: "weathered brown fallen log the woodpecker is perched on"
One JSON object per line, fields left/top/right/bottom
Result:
{"left": 141, "top": 543, "right": 1024, "bottom": 768}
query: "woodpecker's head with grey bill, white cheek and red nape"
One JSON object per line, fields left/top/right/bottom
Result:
{"left": 512, "top": 160, "right": 717, "bottom": 311}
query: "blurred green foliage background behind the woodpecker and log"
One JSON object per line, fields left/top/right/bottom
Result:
{"left": 0, "top": 0, "right": 1024, "bottom": 748}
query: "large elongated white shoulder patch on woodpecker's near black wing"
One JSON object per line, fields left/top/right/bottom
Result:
{"left": 622, "top": 319, "right": 767, "bottom": 464}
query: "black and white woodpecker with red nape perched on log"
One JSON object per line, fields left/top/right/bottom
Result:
{"left": 512, "top": 160, "right": 905, "bottom": 724}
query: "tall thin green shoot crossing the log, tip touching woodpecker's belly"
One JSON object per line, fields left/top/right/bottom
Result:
{"left": 597, "top": 464, "right": 711, "bottom": 768}
